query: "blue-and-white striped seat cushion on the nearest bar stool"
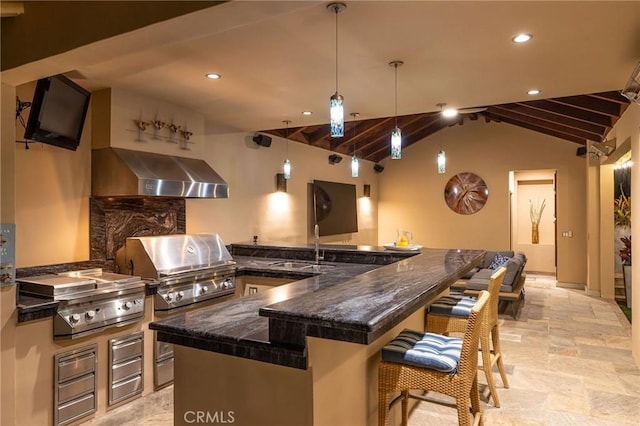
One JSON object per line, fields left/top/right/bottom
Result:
{"left": 382, "top": 329, "right": 462, "bottom": 374}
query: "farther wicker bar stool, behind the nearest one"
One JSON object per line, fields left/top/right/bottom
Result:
{"left": 425, "top": 267, "right": 509, "bottom": 407}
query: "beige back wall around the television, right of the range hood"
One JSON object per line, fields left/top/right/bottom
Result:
{"left": 187, "top": 133, "right": 378, "bottom": 244}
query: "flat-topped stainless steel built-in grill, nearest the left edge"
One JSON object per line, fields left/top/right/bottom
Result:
{"left": 18, "top": 268, "right": 145, "bottom": 339}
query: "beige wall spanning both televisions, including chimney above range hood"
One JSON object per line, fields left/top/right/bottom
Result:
{"left": 15, "top": 83, "right": 377, "bottom": 267}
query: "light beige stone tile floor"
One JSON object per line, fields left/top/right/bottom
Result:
{"left": 85, "top": 275, "right": 640, "bottom": 426}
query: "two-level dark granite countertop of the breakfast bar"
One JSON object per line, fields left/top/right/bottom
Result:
{"left": 150, "top": 244, "right": 484, "bottom": 369}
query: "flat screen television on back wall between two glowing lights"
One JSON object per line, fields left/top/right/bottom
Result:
{"left": 313, "top": 180, "right": 358, "bottom": 236}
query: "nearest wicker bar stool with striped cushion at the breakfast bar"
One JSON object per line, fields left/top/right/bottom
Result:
{"left": 378, "top": 291, "right": 489, "bottom": 426}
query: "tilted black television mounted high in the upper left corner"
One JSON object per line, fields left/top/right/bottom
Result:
{"left": 24, "top": 74, "right": 91, "bottom": 151}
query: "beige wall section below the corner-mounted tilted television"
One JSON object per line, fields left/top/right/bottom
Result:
{"left": 15, "top": 83, "right": 91, "bottom": 267}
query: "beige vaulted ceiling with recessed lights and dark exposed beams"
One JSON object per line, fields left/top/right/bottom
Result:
{"left": 1, "top": 0, "right": 640, "bottom": 161}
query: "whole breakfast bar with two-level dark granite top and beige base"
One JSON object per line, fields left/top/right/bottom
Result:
{"left": 150, "top": 249, "right": 484, "bottom": 425}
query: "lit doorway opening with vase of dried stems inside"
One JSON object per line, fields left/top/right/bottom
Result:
{"left": 509, "top": 169, "right": 557, "bottom": 277}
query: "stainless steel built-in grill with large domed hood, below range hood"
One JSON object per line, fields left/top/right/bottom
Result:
{"left": 116, "top": 234, "right": 236, "bottom": 311}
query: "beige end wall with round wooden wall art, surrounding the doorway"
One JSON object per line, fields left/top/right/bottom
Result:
{"left": 378, "top": 120, "right": 586, "bottom": 284}
